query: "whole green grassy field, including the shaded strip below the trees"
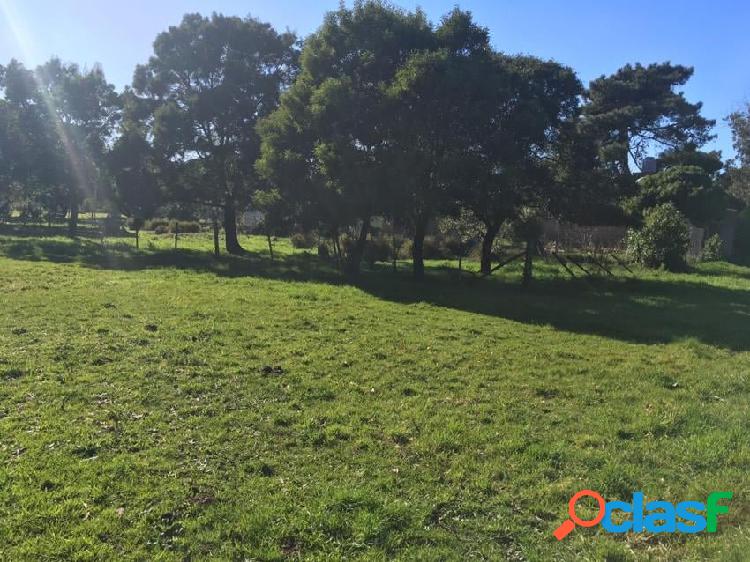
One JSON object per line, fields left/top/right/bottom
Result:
{"left": 0, "top": 225, "right": 750, "bottom": 561}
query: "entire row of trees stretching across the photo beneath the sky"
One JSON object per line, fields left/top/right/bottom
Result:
{"left": 0, "top": 1, "right": 750, "bottom": 277}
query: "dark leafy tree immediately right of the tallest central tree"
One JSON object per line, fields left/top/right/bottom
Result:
{"left": 388, "top": 9, "right": 500, "bottom": 279}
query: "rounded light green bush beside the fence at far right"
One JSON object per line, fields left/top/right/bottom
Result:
{"left": 627, "top": 203, "right": 690, "bottom": 271}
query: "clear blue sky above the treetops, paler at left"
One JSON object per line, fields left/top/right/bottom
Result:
{"left": 0, "top": 0, "right": 750, "bottom": 156}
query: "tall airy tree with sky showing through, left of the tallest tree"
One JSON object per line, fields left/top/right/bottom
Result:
{"left": 133, "top": 14, "right": 296, "bottom": 253}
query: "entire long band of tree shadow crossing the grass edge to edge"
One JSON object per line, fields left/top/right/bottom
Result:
{"left": 0, "top": 232, "right": 750, "bottom": 351}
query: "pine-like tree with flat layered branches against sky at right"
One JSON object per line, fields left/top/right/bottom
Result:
{"left": 585, "top": 62, "right": 715, "bottom": 176}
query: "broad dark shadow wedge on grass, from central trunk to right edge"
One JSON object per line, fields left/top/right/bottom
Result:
{"left": 360, "top": 266, "right": 750, "bottom": 351}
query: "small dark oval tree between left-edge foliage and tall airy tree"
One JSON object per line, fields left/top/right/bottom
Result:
{"left": 108, "top": 128, "right": 160, "bottom": 248}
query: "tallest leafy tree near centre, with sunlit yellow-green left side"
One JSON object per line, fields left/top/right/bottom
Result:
{"left": 259, "top": 1, "right": 433, "bottom": 274}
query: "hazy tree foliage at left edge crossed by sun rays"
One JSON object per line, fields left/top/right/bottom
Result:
{"left": 0, "top": 59, "right": 119, "bottom": 232}
